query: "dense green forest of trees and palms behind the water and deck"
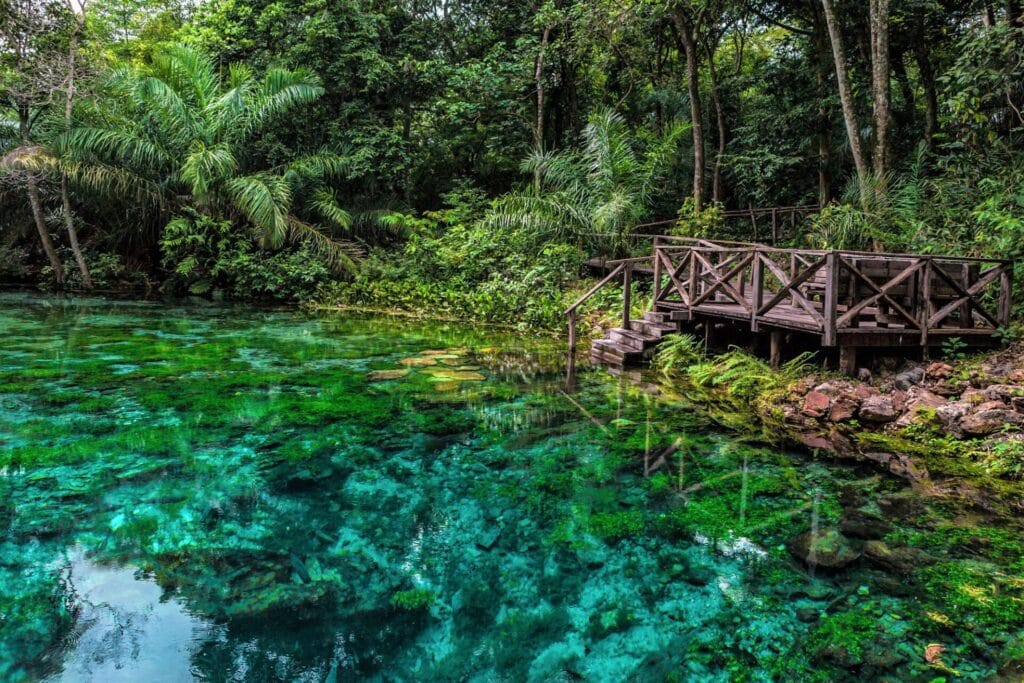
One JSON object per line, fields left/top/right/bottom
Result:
{"left": 0, "top": 0, "right": 1024, "bottom": 325}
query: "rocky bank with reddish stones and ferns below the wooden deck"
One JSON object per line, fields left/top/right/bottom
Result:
{"left": 659, "top": 342, "right": 1024, "bottom": 511}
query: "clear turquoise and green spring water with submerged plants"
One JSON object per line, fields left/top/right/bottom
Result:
{"left": 0, "top": 295, "right": 1024, "bottom": 681}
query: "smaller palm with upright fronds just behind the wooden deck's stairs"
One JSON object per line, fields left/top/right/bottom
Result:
{"left": 485, "top": 111, "right": 685, "bottom": 250}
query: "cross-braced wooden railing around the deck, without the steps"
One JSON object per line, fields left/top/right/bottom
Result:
{"left": 653, "top": 239, "right": 1013, "bottom": 346}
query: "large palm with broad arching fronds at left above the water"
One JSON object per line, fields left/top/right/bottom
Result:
{"left": 47, "top": 46, "right": 359, "bottom": 267}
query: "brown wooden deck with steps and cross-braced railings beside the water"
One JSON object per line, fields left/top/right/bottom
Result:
{"left": 565, "top": 236, "right": 1013, "bottom": 372}
